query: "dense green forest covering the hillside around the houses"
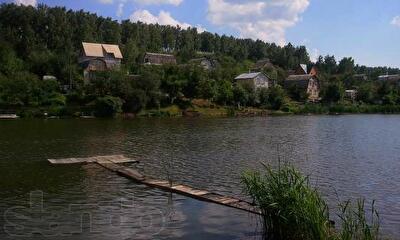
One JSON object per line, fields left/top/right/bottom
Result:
{"left": 0, "top": 4, "right": 400, "bottom": 116}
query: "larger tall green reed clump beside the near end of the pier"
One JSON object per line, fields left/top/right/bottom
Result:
{"left": 242, "top": 166, "right": 330, "bottom": 239}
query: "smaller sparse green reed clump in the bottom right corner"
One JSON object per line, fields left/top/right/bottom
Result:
{"left": 338, "top": 199, "right": 380, "bottom": 240}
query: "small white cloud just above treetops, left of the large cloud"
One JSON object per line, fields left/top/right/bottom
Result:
{"left": 129, "top": 10, "right": 205, "bottom": 32}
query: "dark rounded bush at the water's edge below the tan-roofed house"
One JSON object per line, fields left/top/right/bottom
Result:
{"left": 95, "top": 96, "right": 123, "bottom": 117}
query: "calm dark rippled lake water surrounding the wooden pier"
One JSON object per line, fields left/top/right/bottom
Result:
{"left": 0, "top": 115, "right": 400, "bottom": 239}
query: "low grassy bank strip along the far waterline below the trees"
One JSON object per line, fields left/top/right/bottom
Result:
{"left": 6, "top": 103, "right": 400, "bottom": 118}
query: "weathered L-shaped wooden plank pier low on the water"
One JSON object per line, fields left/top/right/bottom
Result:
{"left": 48, "top": 155, "right": 261, "bottom": 214}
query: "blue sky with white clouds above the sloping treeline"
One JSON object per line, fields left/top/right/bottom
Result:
{"left": 0, "top": 0, "right": 400, "bottom": 67}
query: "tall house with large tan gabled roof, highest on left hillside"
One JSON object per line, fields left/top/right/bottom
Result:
{"left": 79, "top": 42, "right": 123, "bottom": 83}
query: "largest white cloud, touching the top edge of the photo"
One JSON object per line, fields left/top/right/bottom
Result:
{"left": 208, "top": 0, "right": 310, "bottom": 45}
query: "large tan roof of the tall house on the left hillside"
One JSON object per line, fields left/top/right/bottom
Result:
{"left": 82, "top": 42, "right": 123, "bottom": 59}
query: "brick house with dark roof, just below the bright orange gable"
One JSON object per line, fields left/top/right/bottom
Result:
{"left": 284, "top": 74, "right": 321, "bottom": 101}
